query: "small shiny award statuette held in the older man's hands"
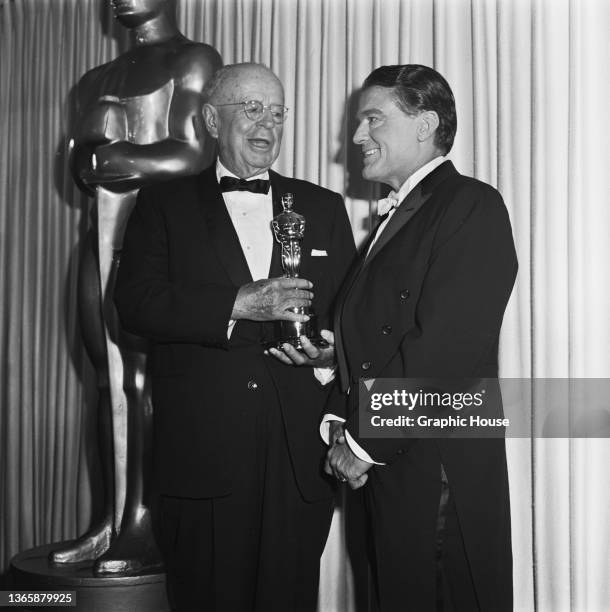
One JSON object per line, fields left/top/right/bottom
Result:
{"left": 270, "top": 193, "right": 328, "bottom": 350}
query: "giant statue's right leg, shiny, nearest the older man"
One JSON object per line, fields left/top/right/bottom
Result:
{"left": 95, "top": 193, "right": 161, "bottom": 574}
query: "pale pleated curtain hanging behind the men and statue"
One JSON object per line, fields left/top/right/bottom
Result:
{"left": 0, "top": 0, "right": 610, "bottom": 612}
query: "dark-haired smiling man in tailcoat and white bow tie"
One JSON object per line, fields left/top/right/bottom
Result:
{"left": 323, "top": 65, "right": 517, "bottom": 612}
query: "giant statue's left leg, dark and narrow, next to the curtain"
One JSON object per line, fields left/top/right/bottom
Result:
{"left": 50, "top": 230, "right": 114, "bottom": 563}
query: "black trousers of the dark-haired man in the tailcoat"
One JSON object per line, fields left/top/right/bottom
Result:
{"left": 365, "top": 445, "right": 480, "bottom": 612}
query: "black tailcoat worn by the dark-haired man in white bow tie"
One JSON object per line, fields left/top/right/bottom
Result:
{"left": 335, "top": 162, "right": 517, "bottom": 610}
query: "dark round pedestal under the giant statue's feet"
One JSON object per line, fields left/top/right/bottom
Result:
{"left": 9, "top": 542, "right": 170, "bottom": 612}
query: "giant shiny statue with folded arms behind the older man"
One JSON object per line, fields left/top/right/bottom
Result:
{"left": 51, "top": 0, "right": 221, "bottom": 575}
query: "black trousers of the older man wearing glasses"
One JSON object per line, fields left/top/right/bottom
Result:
{"left": 160, "top": 389, "right": 332, "bottom": 612}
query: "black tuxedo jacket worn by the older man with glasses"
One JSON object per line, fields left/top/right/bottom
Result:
{"left": 115, "top": 165, "right": 355, "bottom": 500}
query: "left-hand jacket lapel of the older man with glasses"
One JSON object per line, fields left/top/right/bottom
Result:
{"left": 199, "top": 165, "right": 252, "bottom": 287}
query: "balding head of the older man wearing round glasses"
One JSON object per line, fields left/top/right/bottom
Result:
{"left": 203, "top": 64, "right": 284, "bottom": 178}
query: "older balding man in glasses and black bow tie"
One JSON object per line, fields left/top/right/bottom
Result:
{"left": 115, "top": 64, "right": 355, "bottom": 612}
